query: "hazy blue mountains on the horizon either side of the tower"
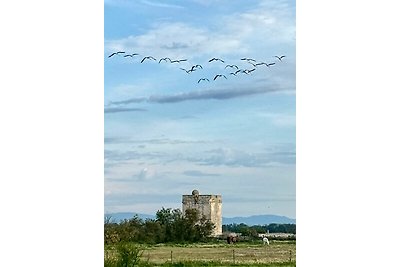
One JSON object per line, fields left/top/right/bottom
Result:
{"left": 105, "top": 212, "right": 296, "bottom": 226}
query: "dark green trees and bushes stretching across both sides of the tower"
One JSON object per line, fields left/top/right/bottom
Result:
{"left": 104, "top": 208, "right": 296, "bottom": 244}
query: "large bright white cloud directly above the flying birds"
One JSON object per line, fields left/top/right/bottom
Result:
{"left": 106, "top": 0, "right": 295, "bottom": 58}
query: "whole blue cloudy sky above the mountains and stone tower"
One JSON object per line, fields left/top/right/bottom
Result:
{"left": 104, "top": 0, "right": 296, "bottom": 218}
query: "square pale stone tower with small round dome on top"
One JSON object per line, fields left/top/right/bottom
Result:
{"left": 182, "top": 190, "right": 222, "bottom": 236}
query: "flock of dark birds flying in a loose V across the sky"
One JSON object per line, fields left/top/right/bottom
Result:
{"left": 108, "top": 51, "right": 285, "bottom": 83}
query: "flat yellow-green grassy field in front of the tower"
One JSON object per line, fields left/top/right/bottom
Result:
{"left": 105, "top": 241, "right": 296, "bottom": 266}
